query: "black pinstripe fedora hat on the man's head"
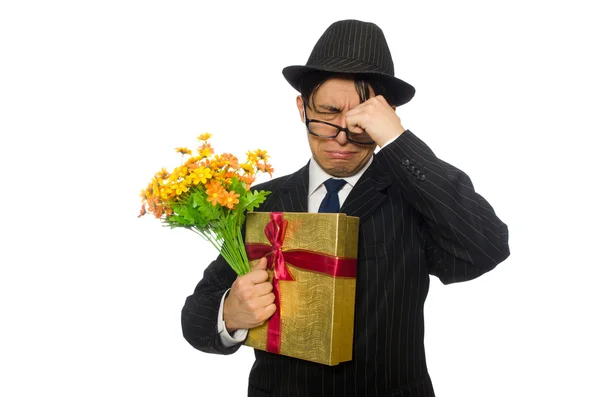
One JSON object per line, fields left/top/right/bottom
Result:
{"left": 283, "top": 20, "right": 415, "bottom": 106}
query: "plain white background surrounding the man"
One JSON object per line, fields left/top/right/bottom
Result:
{"left": 0, "top": 0, "right": 600, "bottom": 397}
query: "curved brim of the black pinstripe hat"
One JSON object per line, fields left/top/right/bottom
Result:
{"left": 282, "top": 65, "right": 415, "bottom": 106}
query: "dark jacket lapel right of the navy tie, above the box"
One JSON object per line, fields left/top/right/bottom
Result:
{"left": 340, "top": 156, "right": 392, "bottom": 223}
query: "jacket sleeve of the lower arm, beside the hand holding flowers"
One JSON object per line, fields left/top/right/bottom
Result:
{"left": 181, "top": 255, "right": 241, "bottom": 354}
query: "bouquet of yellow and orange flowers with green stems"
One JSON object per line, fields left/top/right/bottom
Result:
{"left": 138, "top": 133, "right": 273, "bottom": 275}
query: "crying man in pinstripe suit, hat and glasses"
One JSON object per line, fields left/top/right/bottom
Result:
{"left": 182, "top": 20, "right": 509, "bottom": 397}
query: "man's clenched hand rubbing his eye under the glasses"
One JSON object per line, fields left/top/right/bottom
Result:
{"left": 346, "top": 95, "right": 406, "bottom": 147}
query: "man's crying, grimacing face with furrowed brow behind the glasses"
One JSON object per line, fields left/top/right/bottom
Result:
{"left": 296, "top": 78, "right": 375, "bottom": 178}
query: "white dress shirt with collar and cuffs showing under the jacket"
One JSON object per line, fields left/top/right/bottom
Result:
{"left": 217, "top": 138, "right": 396, "bottom": 347}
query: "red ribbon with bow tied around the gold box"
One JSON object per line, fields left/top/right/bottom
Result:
{"left": 246, "top": 212, "right": 356, "bottom": 354}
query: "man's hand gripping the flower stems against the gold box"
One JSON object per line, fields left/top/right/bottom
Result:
{"left": 223, "top": 258, "right": 275, "bottom": 334}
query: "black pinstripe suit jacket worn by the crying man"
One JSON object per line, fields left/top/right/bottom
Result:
{"left": 182, "top": 131, "right": 509, "bottom": 397}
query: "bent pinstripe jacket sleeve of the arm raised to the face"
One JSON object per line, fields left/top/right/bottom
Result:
{"left": 378, "top": 130, "right": 510, "bottom": 284}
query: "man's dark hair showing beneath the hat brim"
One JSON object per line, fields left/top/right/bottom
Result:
{"left": 299, "top": 71, "right": 391, "bottom": 108}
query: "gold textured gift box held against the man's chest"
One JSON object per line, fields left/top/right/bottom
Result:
{"left": 244, "top": 212, "right": 359, "bottom": 365}
